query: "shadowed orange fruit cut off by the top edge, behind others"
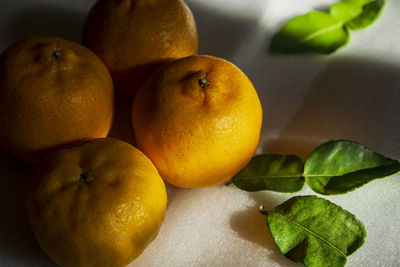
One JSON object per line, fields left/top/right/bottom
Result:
{"left": 83, "top": 0, "right": 198, "bottom": 95}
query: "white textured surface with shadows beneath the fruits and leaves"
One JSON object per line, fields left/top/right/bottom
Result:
{"left": 0, "top": 0, "right": 400, "bottom": 267}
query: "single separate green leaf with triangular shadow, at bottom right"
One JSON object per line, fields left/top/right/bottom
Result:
{"left": 260, "top": 196, "right": 367, "bottom": 267}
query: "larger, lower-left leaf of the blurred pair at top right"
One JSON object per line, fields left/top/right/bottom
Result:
{"left": 270, "top": 11, "right": 349, "bottom": 54}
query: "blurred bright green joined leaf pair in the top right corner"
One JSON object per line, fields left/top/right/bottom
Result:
{"left": 270, "top": 0, "right": 385, "bottom": 54}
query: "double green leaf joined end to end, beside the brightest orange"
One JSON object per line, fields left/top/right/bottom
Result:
{"left": 232, "top": 140, "right": 400, "bottom": 195}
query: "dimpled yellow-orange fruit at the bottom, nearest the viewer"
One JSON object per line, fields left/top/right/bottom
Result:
{"left": 27, "top": 138, "right": 167, "bottom": 267}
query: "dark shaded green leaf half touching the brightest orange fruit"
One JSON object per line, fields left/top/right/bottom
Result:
{"left": 232, "top": 154, "right": 304, "bottom": 193}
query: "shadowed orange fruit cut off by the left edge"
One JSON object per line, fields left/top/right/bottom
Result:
{"left": 0, "top": 37, "right": 114, "bottom": 163}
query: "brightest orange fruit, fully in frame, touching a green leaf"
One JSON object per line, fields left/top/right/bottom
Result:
{"left": 132, "top": 56, "right": 262, "bottom": 187}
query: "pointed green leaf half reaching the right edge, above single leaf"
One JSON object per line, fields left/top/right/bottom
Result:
{"left": 304, "top": 140, "right": 400, "bottom": 195}
